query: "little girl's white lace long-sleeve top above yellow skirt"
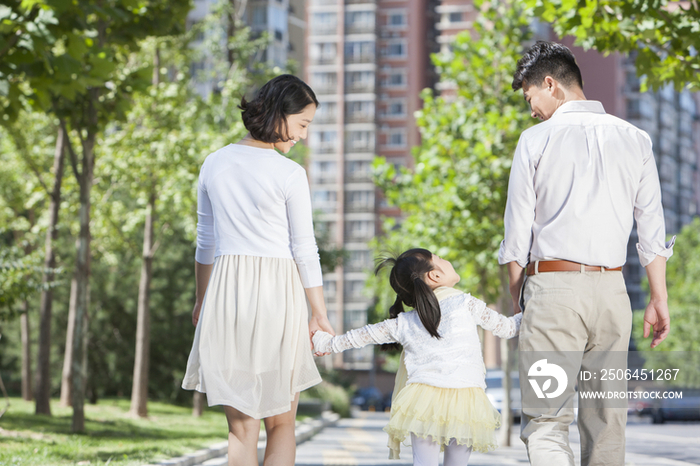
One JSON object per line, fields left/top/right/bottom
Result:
{"left": 313, "top": 290, "right": 522, "bottom": 388}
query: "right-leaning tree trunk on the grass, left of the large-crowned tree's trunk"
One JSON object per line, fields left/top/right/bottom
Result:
{"left": 35, "top": 126, "right": 66, "bottom": 415}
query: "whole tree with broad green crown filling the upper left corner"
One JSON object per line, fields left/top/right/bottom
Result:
{"left": 0, "top": 0, "right": 189, "bottom": 432}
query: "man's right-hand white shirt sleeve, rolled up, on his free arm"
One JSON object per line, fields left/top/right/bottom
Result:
{"left": 634, "top": 141, "right": 676, "bottom": 267}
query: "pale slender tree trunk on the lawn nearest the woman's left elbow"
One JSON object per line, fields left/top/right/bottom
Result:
{"left": 131, "top": 189, "right": 156, "bottom": 417}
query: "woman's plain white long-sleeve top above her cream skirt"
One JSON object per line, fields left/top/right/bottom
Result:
{"left": 195, "top": 144, "right": 323, "bottom": 288}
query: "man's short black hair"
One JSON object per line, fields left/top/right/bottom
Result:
{"left": 513, "top": 40, "right": 583, "bottom": 91}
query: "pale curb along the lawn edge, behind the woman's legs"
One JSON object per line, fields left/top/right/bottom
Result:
{"left": 144, "top": 411, "right": 340, "bottom": 466}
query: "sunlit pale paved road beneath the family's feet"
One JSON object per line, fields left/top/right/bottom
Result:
{"left": 194, "top": 412, "right": 700, "bottom": 466}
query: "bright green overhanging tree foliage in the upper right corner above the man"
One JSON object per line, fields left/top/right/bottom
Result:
{"left": 525, "top": 0, "right": 700, "bottom": 92}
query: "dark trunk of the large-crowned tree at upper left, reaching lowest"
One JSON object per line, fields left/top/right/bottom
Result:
{"left": 71, "top": 123, "right": 97, "bottom": 433}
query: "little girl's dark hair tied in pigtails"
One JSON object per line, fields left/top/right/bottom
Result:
{"left": 375, "top": 249, "right": 442, "bottom": 338}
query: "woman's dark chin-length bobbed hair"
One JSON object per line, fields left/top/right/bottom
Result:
{"left": 238, "top": 74, "right": 318, "bottom": 143}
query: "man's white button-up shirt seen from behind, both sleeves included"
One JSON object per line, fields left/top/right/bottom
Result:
{"left": 498, "top": 100, "right": 675, "bottom": 268}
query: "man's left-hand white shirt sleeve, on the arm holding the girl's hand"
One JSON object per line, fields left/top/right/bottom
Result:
{"left": 498, "top": 135, "right": 536, "bottom": 267}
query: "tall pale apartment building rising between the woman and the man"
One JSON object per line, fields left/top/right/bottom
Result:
{"left": 305, "top": 0, "right": 435, "bottom": 369}
